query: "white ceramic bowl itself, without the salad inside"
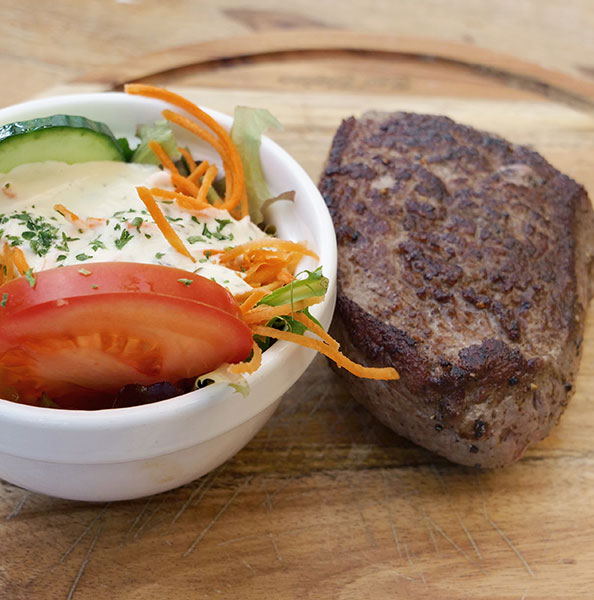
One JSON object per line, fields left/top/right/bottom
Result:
{"left": 0, "top": 93, "right": 336, "bottom": 501}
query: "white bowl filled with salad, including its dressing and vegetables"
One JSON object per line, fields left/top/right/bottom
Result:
{"left": 0, "top": 84, "right": 397, "bottom": 500}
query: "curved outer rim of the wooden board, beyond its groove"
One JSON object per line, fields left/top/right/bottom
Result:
{"left": 72, "top": 29, "right": 594, "bottom": 110}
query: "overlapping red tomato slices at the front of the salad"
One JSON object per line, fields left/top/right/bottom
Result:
{"left": 0, "top": 263, "right": 252, "bottom": 409}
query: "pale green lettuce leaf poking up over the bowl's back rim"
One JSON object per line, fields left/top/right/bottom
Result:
{"left": 231, "top": 106, "right": 281, "bottom": 225}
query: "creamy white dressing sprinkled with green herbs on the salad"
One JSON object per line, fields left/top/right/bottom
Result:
{"left": 0, "top": 161, "right": 266, "bottom": 294}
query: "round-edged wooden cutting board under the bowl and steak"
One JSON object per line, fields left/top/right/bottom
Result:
{"left": 0, "top": 31, "right": 594, "bottom": 600}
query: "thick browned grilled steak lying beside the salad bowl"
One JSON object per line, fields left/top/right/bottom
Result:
{"left": 320, "top": 113, "right": 594, "bottom": 467}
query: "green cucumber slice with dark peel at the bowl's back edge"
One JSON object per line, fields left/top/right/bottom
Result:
{"left": 0, "top": 115, "right": 125, "bottom": 173}
